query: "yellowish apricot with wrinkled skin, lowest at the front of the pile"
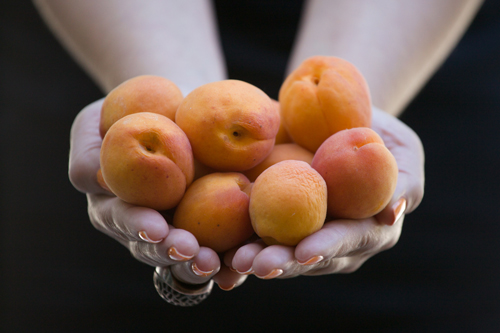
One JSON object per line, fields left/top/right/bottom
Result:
{"left": 249, "top": 160, "right": 327, "bottom": 246}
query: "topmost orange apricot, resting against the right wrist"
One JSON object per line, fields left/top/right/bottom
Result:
{"left": 279, "top": 56, "right": 371, "bottom": 152}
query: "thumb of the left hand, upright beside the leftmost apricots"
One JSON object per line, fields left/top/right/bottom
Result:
{"left": 69, "top": 99, "right": 107, "bottom": 193}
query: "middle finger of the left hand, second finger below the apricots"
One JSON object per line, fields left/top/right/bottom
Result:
{"left": 128, "top": 228, "right": 199, "bottom": 266}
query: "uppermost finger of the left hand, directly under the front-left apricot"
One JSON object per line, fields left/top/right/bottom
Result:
{"left": 87, "top": 194, "right": 169, "bottom": 243}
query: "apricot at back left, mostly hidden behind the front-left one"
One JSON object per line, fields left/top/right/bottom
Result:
{"left": 99, "top": 75, "right": 183, "bottom": 138}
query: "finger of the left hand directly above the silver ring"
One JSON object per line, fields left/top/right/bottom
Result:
{"left": 170, "top": 245, "right": 220, "bottom": 284}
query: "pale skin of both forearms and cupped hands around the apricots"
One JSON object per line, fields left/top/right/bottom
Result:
{"left": 35, "top": 0, "right": 481, "bottom": 290}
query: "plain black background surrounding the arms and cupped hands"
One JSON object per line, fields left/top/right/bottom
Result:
{"left": 0, "top": 0, "right": 500, "bottom": 332}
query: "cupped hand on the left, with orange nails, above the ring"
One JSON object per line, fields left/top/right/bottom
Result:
{"left": 69, "top": 99, "right": 221, "bottom": 285}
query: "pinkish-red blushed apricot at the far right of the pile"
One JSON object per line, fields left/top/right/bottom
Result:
{"left": 311, "top": 127, "right": 398, "bottom": 219}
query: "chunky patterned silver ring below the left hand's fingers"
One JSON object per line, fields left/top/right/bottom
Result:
{"left": 153, "top": 267, "right": 214, "bottom": 306}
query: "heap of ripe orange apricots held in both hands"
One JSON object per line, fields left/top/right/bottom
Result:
{"left": 98, "top": 56, "right": 398, "bottom": 252}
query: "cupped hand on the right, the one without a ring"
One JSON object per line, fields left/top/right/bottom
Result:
{"left": 224, "top": 108, "right": 424, "bottom": 279}
